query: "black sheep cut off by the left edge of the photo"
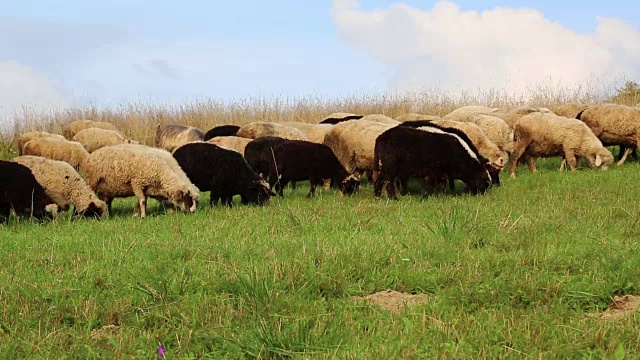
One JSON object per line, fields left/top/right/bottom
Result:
{"left": 0, "top": 160, "right": 53, "bottom": 223}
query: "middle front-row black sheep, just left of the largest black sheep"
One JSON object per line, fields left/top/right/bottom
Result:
{"left": 269, "top": 140, "right": 360, "bottom": 197}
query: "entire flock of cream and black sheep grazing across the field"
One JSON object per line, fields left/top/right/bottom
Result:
{"left": 0, "top": 104, "right": 640, "bottom": 222}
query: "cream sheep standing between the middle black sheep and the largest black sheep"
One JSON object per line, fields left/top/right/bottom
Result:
{"left": 324, "top": 120, "right": 395, "bottom": 176}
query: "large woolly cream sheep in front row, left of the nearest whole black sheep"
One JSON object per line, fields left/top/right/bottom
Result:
{"left": 86, "top": 145, "right": 195, "bottom": 218}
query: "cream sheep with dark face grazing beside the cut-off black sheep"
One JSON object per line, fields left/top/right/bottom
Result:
{"left": 13, "top": 155, "right": 107, "bottom": 217}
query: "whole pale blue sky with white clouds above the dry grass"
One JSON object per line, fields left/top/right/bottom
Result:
{"left": 0, "top": 0, "right": 640, "bottom": 122}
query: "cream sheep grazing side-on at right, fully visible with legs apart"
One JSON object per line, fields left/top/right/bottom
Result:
{"left": 509, "top": 112, "right": 613, "bottom": 177}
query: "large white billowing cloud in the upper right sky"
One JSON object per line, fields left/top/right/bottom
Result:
{"left": 331, "top": 0, "right": 640, "bottom": 91}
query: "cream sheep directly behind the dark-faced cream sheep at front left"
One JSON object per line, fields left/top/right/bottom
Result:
{"left": 22, "top": 137, "right": 89, "bottom": 172}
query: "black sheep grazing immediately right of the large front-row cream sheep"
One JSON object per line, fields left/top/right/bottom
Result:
{"left": 173, "top": 143, "right": 273, "bottom": 206}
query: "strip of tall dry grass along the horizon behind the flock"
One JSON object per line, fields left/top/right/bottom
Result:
{"left": 0, "top": 79, "right": 640, "bottom": 152}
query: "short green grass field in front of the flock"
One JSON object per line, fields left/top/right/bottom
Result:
{"left": 0, "top": 160, "right": 640, "bottom": 359}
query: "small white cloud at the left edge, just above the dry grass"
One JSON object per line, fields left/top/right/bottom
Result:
{"left": 0, "top": 61, "right": 69, "bottom": 129}
